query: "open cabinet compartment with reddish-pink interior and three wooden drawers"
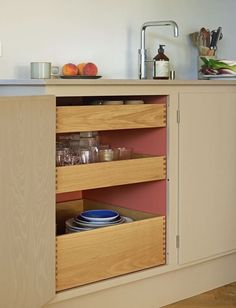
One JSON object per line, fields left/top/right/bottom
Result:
{"left": 56, "top": 96, "right": 167, "bottom": 291}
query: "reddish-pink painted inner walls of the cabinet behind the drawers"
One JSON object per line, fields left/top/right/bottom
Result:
{"left": 56, "top": 96, "right": 168, "bottom": 215}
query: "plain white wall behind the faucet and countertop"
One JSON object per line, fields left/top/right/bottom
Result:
{"left": 0, "top": 0, "right": 236, "bottom": 79}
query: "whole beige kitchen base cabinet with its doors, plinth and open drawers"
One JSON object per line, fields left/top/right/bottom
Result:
{"left": 0, "top": 80, "right": 236, "bottom": 308}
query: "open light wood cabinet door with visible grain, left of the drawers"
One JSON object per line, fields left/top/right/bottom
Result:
{"left": 0, "top": 96, "right": 55, "bottom": 308}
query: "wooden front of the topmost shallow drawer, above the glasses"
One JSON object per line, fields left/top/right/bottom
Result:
{"left": 56, "top": 104, "right": 166, "bottom": 133}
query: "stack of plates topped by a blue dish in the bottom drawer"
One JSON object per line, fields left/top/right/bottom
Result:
{"left": 65, "top": 209, "right": 133, "bottom": 233}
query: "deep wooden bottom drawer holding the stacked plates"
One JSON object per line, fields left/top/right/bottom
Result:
{"left": 56, "top": 200, "right": 165, "bottom": 291}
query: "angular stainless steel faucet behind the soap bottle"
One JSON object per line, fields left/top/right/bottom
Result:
{"left": 139, "top": 20, "right": 179, "bottom": 79}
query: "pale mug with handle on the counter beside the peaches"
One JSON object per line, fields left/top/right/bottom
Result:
{"left": 30, "top": 62, "right": 59, "bottom": 79}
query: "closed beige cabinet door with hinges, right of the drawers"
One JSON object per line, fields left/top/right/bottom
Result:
{"left": 179, "top": 90, "right": 236, "bottom": 264}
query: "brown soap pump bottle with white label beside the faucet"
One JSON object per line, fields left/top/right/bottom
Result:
{"left": 153, "top": 45, "right": 170, "bottom": 79}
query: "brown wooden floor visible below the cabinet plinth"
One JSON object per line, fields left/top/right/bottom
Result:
{"left": 163, "top": 282, "right": 236, "bottom": 308}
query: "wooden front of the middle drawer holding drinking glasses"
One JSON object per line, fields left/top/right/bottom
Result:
{"left": 56, "top": 156, "right": 166, "bottom": 193}
